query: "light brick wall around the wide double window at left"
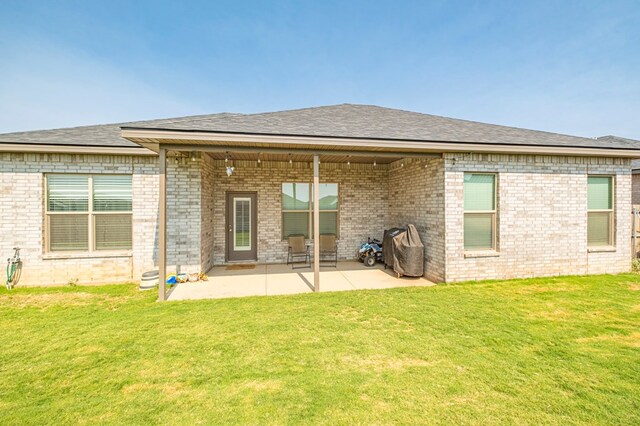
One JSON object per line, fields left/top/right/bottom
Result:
{"left": 0, "top": 153, "right": 157, "bottom": 285}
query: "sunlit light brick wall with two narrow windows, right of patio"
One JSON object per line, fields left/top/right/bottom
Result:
{"left": 444, "top": 154, "right": 631, "bottom": 281}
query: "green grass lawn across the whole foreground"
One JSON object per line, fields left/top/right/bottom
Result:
{"left": 0, "top": 274, "right": 640, "bottom": 425}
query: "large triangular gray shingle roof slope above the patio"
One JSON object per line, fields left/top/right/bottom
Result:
{"left": 124, "top": 104, "right": 638, "bottom": 148}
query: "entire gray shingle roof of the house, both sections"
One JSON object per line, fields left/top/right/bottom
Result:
{"left": 0, "top": 104, "right": 640, "bottom": 149}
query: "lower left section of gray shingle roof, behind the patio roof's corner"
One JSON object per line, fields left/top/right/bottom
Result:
{"left": 0, "top": 113, "right": 239, "bottom": 148}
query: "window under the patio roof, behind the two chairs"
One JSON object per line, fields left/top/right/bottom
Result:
{"left": 282, "top": 183, "right": 338, "bottom": 238}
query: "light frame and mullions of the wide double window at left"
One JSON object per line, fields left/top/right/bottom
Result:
{"left": 44, "top": 173, "right": 134, "bottom": 253}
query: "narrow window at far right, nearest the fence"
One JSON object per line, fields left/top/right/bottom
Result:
{"left": 587, "top": 176, "right": 614, "bottom": 247}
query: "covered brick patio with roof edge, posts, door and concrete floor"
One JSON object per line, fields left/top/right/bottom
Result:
{"left": 122, "top": 110, "right": 444, "bottom": 301}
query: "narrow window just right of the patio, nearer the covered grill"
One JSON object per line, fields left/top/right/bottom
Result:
{"left": 464, "top": 173, "right": 496, "bottom": 250}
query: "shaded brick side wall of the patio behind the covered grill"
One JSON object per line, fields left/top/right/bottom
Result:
{"left": 386, "top": 158, "right": 445, "bottom": 282}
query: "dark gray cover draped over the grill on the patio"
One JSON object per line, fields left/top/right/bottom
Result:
{"left": 382, "top": 225, "right": 424, "bottom": 277}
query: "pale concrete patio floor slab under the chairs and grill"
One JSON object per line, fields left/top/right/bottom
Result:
{"left": 167, "top": 261, "right": 434, "bottom": 301}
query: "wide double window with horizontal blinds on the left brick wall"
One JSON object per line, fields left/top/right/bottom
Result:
{"left": 46, "top": 174, "right": 132, "bottom": 252}
